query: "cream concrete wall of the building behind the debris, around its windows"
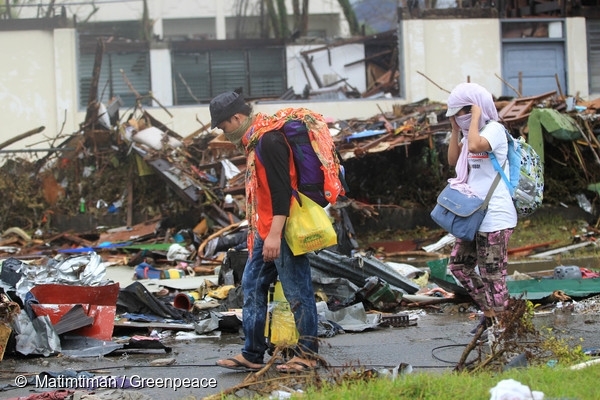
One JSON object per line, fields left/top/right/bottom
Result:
{"left": 0, "top": 18, "right": 588, "bottom": 149}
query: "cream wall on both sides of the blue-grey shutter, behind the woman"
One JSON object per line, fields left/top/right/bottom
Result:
{"left": 402, "top": 18, "right": 594, "bottom": 101}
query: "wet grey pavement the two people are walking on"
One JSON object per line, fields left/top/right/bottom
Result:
{"left": 0, "top": 304, "right": 600, "bottom": 400}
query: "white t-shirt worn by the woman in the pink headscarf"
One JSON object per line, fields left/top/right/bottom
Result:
{"left": 463, "top": 121, "right": 517, "bottom": 232}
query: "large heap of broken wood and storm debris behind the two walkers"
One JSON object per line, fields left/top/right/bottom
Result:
{"left": 0, "top": 77, "right": 600, "bottom": 366}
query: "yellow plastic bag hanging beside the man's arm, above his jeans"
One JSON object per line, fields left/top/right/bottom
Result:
{"left": 284, "top": 192, "right": 337, "bottom": 256}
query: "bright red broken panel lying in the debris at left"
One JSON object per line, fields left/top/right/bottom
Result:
{"left": 31, "top": 283, "right": 119, "bottom": 340}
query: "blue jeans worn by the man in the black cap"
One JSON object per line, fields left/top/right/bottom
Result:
{"left": 242, "top": 236, "right": 319, "bottom": 364}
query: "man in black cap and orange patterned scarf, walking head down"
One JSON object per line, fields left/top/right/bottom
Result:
{"left": 209, "top": 91, "right": 318, "bottom": 372}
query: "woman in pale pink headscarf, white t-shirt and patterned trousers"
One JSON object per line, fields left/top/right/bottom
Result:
{"left": 446, "top": 83, "right": 517, "bottom": 341}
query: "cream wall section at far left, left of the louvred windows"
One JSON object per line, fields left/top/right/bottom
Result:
{"left": 0, "top": 29, "right": 81, "bottom": 149}
